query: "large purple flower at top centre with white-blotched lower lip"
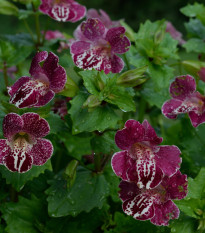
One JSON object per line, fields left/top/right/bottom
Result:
{"left": 70, "top": 18, "right": 130, "bottom": 74}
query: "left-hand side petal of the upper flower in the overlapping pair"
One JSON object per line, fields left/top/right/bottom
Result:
{"left": 111, "top": 151, "right": 135, "bottom": 180}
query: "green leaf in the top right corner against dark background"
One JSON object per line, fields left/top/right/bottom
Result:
{"left": 180, "top": 2, "right": 205, "bottom": 24}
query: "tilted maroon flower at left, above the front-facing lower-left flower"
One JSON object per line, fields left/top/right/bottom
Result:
{"left": 8, "top": 51, "right": 67, "bottom": 108}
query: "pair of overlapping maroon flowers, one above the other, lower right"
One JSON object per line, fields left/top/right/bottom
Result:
{"left": 112, "top": 120, "right": 187, "bottom": 225}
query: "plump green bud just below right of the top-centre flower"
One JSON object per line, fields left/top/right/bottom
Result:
{"left": 117, "top": 66, "right": 147, "bottom": 87}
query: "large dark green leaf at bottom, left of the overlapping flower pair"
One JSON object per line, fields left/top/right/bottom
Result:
{"left": 46, "top": 167, "right": 109, "bottom": 217}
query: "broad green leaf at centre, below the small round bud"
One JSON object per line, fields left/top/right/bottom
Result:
{"left": 68, "top": 92, "right": 120, "bottom": 134}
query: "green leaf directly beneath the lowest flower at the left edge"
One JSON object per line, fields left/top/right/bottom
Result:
{"left": 0, "top": 160, "right": 52, "bottom": 192}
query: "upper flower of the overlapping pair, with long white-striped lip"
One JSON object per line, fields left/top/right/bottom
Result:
{"left": 112, "top": 120, "right": 181, "bottom": 189}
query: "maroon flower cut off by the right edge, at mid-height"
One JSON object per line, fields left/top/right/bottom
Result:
{"left": 162, "top": 75, "right": 205, "bottom": 127}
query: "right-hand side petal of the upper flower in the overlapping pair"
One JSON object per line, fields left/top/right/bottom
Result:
{"left": 154, "top": 146, "right": 182, "bottom": 176}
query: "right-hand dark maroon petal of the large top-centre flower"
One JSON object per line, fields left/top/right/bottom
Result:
{"left": 105, "top": 27, "right": 131, "bottom": 54}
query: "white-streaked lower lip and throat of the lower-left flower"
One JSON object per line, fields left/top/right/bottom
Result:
{"left": 3, "top": 138, "right": 33, "bottom": 173}
